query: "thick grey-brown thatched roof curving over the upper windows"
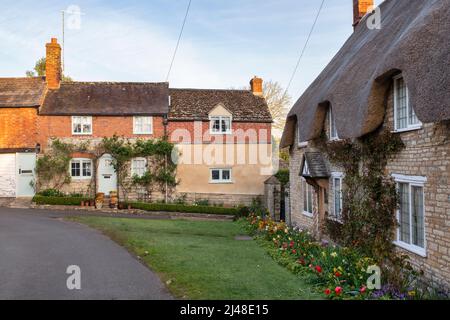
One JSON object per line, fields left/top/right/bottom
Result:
{"left": 281, "top": 0, "right": 450, "bottom": 147}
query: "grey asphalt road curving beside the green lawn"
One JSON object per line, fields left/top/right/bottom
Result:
{"left": 0, "top": 207, "right": 172, "bottom": 300}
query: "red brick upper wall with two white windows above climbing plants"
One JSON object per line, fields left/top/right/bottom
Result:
{"left": 38, "top": 116, "right": 164, "bottom": 148}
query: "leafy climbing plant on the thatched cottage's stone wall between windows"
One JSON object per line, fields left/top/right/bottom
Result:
{"left": 321, "top": 131, "right": 412, "bottom": 284}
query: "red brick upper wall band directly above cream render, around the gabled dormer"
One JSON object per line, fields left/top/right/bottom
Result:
{"left": 168, "top": 121, "right": 272, "bottom": 143}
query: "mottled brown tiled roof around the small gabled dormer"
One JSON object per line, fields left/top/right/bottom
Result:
{"left": 169, "top": 89, "right": 272, "bottom": 123}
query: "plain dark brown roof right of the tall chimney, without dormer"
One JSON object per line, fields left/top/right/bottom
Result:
{"left": 40, "top": 82, "right": 169, "bottom": 115}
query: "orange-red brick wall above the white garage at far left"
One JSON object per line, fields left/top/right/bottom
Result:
{"left": 0, "top": 108, "right": 37, "bottom": 149}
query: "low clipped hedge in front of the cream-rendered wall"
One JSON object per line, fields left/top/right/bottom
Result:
{"left": 127, "top": 202, "right": 238, "bottom": 216}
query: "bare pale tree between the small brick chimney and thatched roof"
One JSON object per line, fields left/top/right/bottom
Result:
{"left": 263, "top": 81, "right": 292, "bottom": 130}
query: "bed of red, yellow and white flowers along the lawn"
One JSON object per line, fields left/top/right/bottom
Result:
{"left": 241, "top": 215, "right": 420, "bottom": 299}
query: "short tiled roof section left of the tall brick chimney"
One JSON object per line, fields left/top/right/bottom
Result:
{"left": 0, "top": 77, "right": 46, "bottom": 108}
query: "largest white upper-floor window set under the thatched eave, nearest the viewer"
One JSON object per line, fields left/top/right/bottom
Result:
{"left": 394, "top": 75, "right": 422, "bottom": 131}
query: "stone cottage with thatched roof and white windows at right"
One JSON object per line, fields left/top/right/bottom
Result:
{"left": 281, "top": 0, "right": 450, "bottom": 289}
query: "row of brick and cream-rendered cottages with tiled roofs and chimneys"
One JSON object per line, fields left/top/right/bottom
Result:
{"left": 0, "top": 39, "right": 272, "bottom": 206}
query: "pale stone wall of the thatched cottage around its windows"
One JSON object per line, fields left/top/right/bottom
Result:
{"left": 290, "top": 85, "right": 450, "bottom": 290}
